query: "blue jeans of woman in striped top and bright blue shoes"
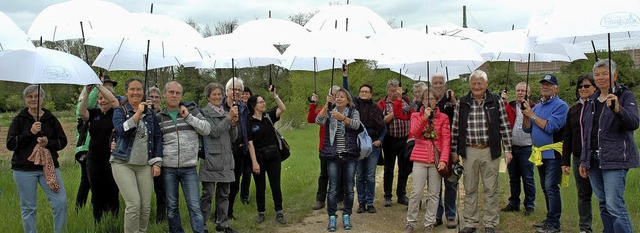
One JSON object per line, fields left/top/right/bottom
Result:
{"left": 327, "top": 156, "right": 358, "bottom": 216}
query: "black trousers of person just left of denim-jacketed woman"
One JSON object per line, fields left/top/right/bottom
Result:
{"left": 86, "top": 157, "right": 120, "bottom": 222}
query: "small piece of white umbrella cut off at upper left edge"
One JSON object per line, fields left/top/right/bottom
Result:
{"left": 0, "top": 12, "right": 34, "bottom": 50}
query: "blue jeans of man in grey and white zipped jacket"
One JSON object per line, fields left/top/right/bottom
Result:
{"left": 162, "top": 167, "right": 204, "bottom": 233}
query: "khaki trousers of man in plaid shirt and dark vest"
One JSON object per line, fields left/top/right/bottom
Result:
{"left": 462, "top": 147, "right": 500, "bottom": 228}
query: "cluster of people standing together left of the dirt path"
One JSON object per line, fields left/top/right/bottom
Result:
{"left": 7, "top": 78, "right": 286, "bottom": 232}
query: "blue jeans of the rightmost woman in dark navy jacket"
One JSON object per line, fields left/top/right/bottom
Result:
{"left": 589, "top": 158, "right": 633, "bottom": 233}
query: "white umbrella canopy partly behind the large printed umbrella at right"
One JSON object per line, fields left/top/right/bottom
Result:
{"left": 482, "top": 29, "right": 587, "bottom": 62}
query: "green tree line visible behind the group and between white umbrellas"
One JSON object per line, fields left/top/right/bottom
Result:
{"left": 0, "top": 12, "right": 640, "bottom": 132}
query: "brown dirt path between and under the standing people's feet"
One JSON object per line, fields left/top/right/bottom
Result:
{"left": 278, "top": 167, "right": 462, "bottom": 233}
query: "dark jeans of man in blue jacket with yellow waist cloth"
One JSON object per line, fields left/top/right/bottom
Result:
{"left": 538, "top": 159, "right": 562, "bottom": 228}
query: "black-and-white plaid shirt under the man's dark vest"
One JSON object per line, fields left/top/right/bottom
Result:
{"left": 451, "top": 94, "right": 511, "bottom": 154}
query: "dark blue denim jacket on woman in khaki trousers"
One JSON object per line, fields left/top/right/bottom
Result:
{"left": 111, "top": 102, "right": 162, "bottom": 165}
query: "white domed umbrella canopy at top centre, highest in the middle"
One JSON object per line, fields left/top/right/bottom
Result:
{"left": 304, "top": 5, "right": 391, "bottom": 37}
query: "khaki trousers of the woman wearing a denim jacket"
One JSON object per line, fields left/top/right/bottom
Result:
{"left": 111, "top": 163, "right": 153, "bottom": 233}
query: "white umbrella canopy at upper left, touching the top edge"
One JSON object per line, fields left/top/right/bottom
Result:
{"left": 28, "top": 0, "right": 129, "bottom": 41}
